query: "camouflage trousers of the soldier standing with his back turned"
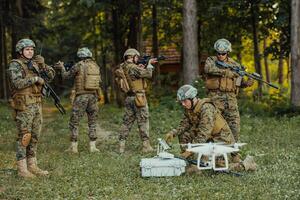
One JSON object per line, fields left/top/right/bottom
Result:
{"left": 69, "top": 94, "right": 99, "bottom": 142}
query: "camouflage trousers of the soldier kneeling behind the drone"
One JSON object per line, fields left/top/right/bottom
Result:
{"left": 178, "top": 125, "right": 235, "bottom": 151}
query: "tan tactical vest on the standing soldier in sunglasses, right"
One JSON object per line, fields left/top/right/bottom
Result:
{"left": 205, "top": 56, "right": 241, "bottom": 93}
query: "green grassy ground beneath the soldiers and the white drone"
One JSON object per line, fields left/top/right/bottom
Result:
{"left": 0, "top": 100, "right": 300, "bottom": 199}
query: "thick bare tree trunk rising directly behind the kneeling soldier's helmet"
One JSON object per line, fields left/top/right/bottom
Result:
{"left": 183, "top": 0, "right": 199, "bottom": 84}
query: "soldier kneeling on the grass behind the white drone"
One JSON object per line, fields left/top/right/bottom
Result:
{"left": 166, "top": 85, "right": 256, "bottom": 172}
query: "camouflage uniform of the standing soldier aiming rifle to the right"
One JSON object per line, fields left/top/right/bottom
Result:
{"left": 119, "top": 61, "right": 152, "bottom": 141}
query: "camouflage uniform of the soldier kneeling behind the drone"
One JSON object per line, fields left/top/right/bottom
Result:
{"left": 172, "top": 99, "right": 234, "bottom": 150}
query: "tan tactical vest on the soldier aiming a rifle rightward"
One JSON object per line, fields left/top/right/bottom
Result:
{"left": 123, "top": 63, "right": 147, "bottom": 93}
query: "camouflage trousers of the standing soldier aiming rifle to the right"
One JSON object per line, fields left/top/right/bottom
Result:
{"left": 119, "top": 96, "right": 149, "bottom": 141}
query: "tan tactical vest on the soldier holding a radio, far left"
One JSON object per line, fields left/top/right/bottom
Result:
{"left": 9, "top": 59, "right": 42, "bottom": 111}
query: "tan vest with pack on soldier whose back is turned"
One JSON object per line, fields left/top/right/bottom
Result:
{"left": 75, "top": 59, "right": 101, "bottom": 95}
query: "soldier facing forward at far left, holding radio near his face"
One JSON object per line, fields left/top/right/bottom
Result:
{"left": 7, "top": 39, "right": 55, "bottom": 178}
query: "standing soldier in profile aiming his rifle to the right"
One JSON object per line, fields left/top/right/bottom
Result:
{"left": 119, "top": 49, "right": 157, "bottom": 153}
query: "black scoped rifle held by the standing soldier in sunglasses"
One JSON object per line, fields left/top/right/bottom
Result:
{"left": 216, "top": 60, "right": 279, "bottom": 90}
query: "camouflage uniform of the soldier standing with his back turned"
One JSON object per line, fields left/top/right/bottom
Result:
{"left": 62, "top": 58, "right": 101, "bottom": 142}
